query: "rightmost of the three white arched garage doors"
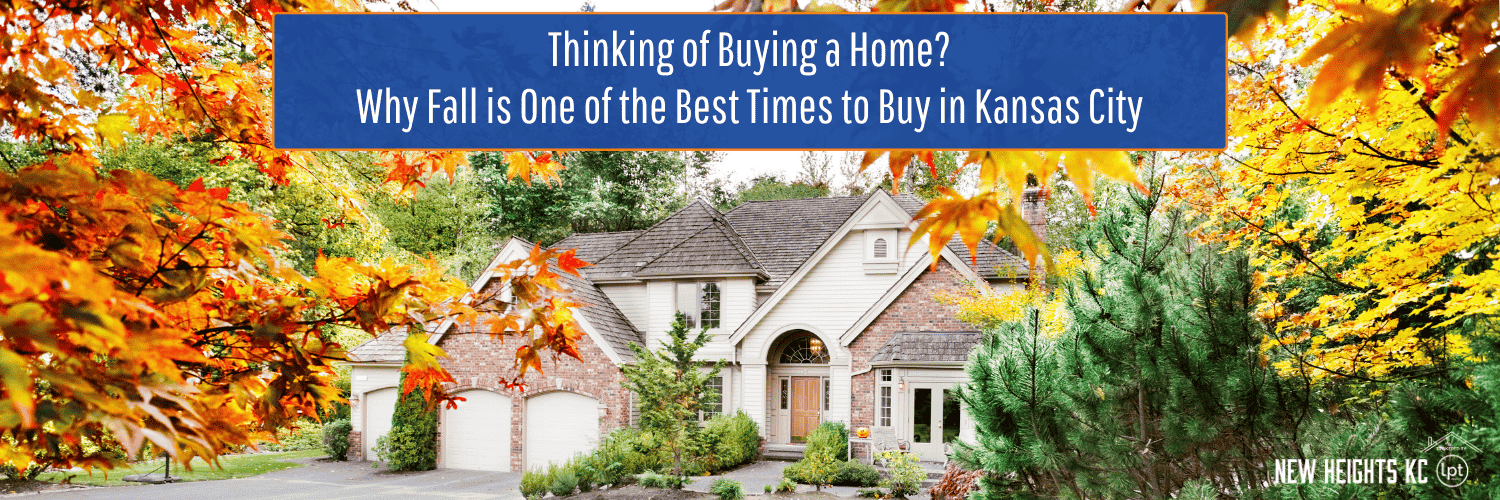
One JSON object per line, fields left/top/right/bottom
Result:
{"left": 527, "top": 392, "right": 599, "bottom": 470}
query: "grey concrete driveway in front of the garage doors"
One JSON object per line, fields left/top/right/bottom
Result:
{"left": 35, "top": 458, "right": 522, "bottom": 500}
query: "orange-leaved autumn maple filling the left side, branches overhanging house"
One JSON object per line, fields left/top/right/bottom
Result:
{"left": 0, "top": 0, "right": 585, "bottom": 470}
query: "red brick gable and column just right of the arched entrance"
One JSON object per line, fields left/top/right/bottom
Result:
{"left": 849, "top": 261, "right": 974, "bottom": 458}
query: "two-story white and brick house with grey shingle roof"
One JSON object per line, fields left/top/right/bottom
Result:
{"left": 350, "top": 192, "right": 1044, "bottom": 470}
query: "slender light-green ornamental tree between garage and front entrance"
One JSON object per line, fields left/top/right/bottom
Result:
{"left": 626, "top": 312, "right": 725, "bottom": 476}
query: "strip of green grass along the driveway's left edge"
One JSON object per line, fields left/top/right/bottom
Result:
{"left": 36, "top": 450, "right": 327, "bottom": 486}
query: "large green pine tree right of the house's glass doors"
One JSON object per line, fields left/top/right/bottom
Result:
{"left": 959, "top": 180, "right": 1305, "bottom": 498}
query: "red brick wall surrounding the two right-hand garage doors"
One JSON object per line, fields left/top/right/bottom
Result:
{"left": 438, "top": 325, "right": 630, "bottom": 471}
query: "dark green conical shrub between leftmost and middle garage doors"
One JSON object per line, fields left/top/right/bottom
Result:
{"left": 375, "top": 364, "right": 438, "bottom": 470}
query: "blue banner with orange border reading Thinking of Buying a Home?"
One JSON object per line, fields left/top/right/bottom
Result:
{"left": 275, "top": 14, "right": 1227, "bottom": 150}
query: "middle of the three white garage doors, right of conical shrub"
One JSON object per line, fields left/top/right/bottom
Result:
{"left": 443, "top": 390, "right": 510, "bottom": 471}
